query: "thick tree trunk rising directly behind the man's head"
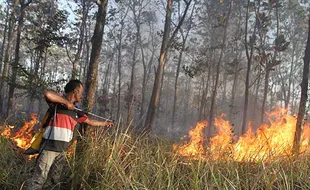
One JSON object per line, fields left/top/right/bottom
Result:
{"left": 83, "top": 0, "right": 108, "bottom": 130}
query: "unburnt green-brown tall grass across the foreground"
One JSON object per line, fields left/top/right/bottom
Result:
{"left": 0, "top": 125, "right": 310, "bottom": 190}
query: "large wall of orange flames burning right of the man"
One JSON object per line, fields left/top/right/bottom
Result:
{"left": 174, "top": 109, "right": 310, "bottom": 162}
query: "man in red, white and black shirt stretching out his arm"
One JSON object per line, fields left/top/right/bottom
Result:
{"left": 27, "top": 80, "right": 113, "bottom": 190}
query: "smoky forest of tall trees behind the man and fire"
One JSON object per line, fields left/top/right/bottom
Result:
{"left": 0, "top": 0, "right": 308, "bottom": 140}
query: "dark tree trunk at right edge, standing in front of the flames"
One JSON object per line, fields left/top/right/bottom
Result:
{"left": 293, "top": 15, "right": 310, "bottom": 156}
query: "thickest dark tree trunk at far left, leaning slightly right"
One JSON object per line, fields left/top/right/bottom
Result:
{"left": 7, "top": 0, "right": 32, "bottom": 117}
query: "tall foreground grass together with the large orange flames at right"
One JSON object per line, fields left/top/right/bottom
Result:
{"left": 0, "top": 108, "right": 310, "bottom": 190}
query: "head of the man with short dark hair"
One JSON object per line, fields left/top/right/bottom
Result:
{"left": 65, "top": 79, "right": 84, "bottom": 102}
